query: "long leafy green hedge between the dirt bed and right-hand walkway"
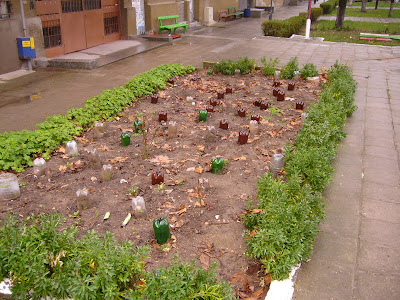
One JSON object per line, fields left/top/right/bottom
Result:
{"left": 244, "top": 63, "right": 356, "bottom": 280}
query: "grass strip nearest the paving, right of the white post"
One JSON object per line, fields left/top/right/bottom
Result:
{"left": 310, "top": 20, "right": 400, "bottom": 46}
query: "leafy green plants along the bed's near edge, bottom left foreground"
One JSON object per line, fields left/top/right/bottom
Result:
{"left": 0, "top": 214, "right": 234, "bottom": 299}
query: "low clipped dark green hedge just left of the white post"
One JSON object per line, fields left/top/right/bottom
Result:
{"left": 261, "top": 16, "right": 307, "bottom": 37}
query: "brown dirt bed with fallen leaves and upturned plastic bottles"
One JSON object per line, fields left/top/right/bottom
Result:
{"left": 1, "top": 71, "right": 321, "bottom": 297}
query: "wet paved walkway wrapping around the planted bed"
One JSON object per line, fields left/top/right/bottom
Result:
{"left": 0, "top": 6, "right": 400, "bottom": 300}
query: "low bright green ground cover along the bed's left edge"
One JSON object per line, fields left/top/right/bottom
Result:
{"left": 0, "top": 64, "right": 194, "bottom": 172}
